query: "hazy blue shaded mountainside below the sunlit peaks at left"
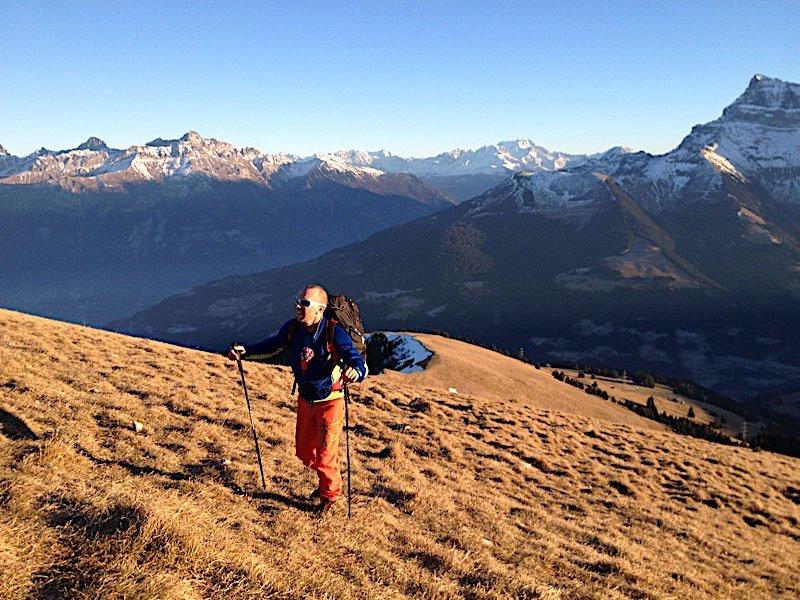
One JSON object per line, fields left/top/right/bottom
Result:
{"left": 0, "top": 159, "right": 451, "bottom": 323}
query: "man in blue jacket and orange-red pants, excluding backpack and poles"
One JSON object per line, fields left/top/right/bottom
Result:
{"left": 228, "top": 285, "right": 367, "bottom": 513}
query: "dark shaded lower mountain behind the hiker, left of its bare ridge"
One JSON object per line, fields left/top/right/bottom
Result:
{"left": 113, "top": 174, "right": 788, "bottom": 396}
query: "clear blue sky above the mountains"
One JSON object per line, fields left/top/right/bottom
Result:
{"left": 0, "top": 0, "right": 800, "bottom": 156}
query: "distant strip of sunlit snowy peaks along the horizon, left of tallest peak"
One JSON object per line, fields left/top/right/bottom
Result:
{"left": 0, "top": 131, "right": 608, "bottom": 202}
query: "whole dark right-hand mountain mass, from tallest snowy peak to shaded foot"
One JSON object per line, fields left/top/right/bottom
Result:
{"left": 115, "top": 75, "right": 800, "bottom": 397}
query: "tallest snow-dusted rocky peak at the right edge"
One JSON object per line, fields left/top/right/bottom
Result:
{"left": 578, "top": 75, "right": 800, "bottom": 212}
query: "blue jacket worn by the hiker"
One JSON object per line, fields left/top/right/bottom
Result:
{"left": 246, "top": 316, "right": 367, "bottom": 402}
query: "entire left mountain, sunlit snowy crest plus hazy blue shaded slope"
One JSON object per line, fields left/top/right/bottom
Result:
{"left": 0, "top": 132, "right": 452, "bottom": 323}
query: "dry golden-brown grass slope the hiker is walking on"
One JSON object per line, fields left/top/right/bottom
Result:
{"left": 0, "top": 311, "right": 800, "bottom": 598}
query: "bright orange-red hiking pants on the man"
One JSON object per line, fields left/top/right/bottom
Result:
{"left": 294, "top": 396, "right": 344, "bottom": 502}
